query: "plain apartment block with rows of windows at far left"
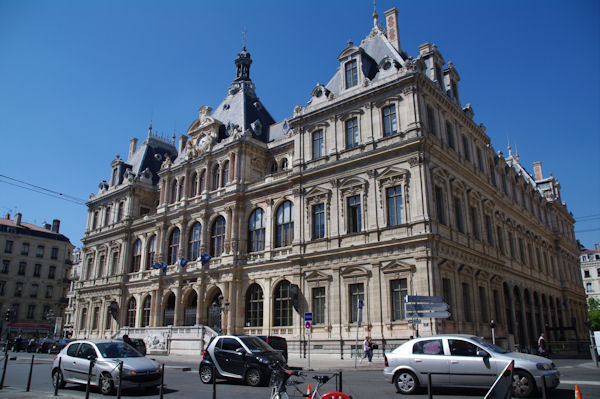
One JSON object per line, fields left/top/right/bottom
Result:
{"left": 0, "top": 213, "right": 73, "bottom": 335}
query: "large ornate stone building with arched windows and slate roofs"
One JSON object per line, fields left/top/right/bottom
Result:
{"left": 75, "top": 8, "right": 586, "bottom": 354}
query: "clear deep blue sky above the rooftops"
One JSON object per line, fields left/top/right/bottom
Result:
{"left": 0, "top": 0, "right": 600, "bottom": 247}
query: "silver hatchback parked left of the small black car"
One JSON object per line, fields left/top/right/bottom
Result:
{"left": 52, "top": 340, "right": 161, "bottom": 395}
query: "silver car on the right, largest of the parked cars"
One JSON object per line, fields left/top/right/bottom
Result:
{"left": 383, "top": 335, "right": 560, "bottom": 397}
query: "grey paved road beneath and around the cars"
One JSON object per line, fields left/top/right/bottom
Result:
{"left": 0, "top": 354, "right": 600, "bottom": 399}
